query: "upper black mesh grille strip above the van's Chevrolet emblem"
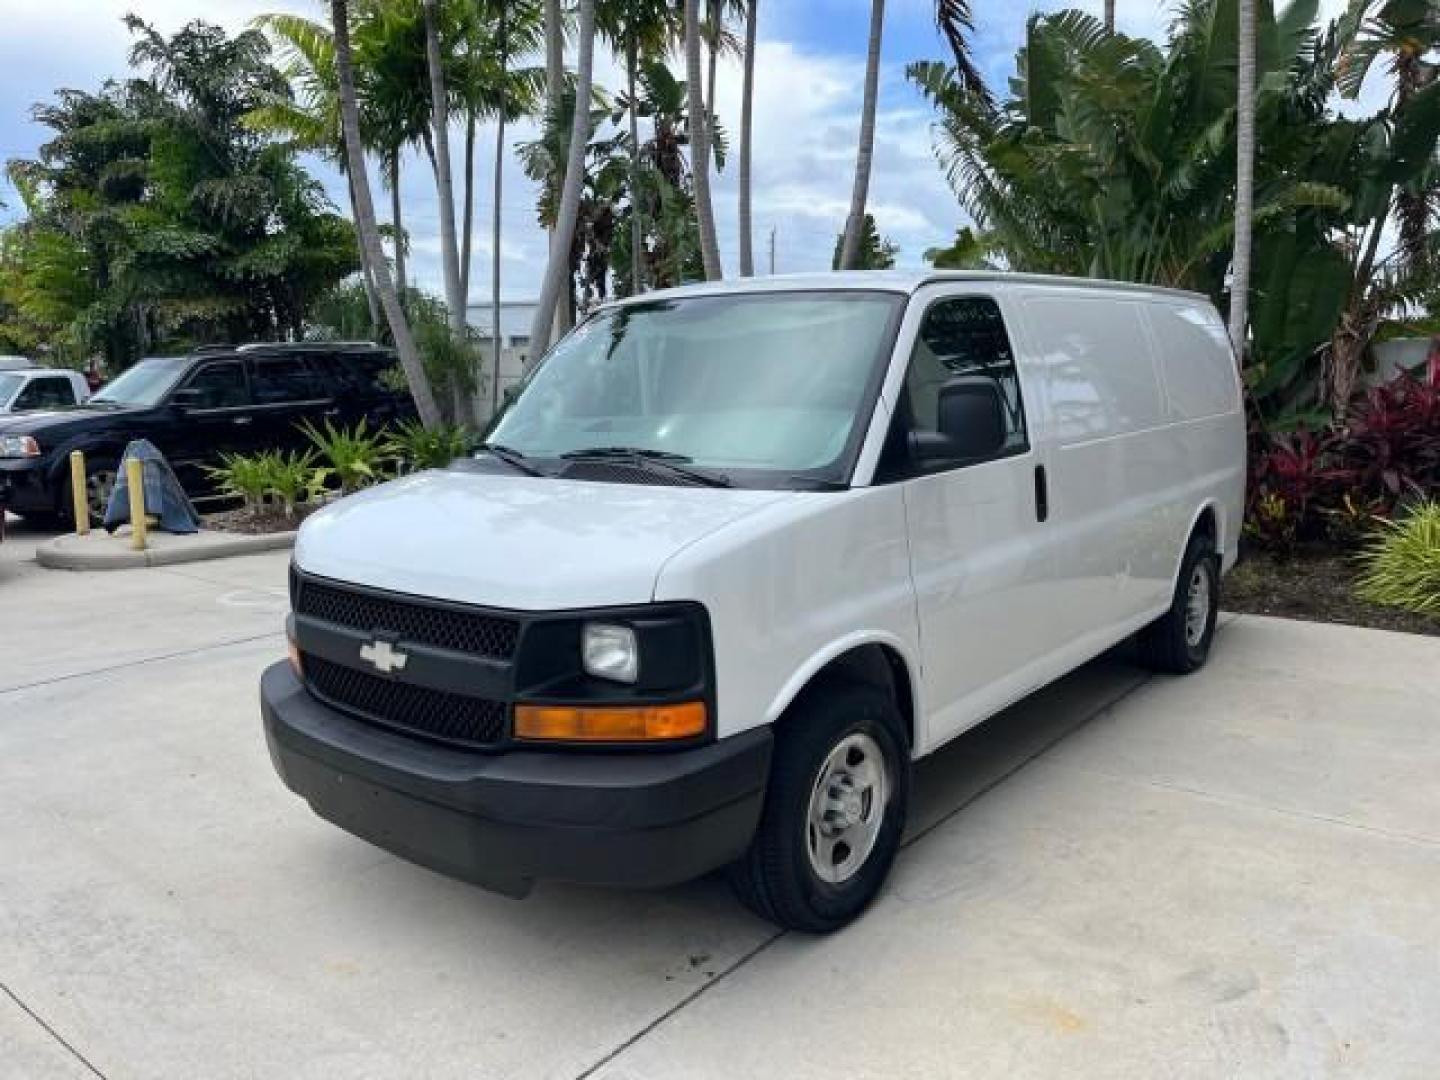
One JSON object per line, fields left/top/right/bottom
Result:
{"left": 294, "top": 577, "right": 520, "bottom": 660}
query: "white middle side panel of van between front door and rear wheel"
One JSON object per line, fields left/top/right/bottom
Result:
{"left": 1024, "top": 289, "right": 1184, "bottom": 642}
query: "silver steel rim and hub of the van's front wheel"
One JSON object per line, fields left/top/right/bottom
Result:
{"left": 805, "top": 734, "right": 890, "bottom": 884}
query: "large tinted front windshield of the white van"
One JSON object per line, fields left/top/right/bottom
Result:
{"left": 487, "top": 292, "right": 903, "bottom": 484}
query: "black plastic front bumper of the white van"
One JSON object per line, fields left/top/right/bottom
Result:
{"left": 261, "top": 662, "right": 772, "bottom": 896}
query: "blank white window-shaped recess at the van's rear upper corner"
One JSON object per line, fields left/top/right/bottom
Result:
{"left": 1149, "top": 304, "right": 1240, "bottom": 420}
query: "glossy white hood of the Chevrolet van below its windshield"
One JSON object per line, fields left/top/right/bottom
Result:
{"left": 295, "top": 469, "right": 793, "bottom": 611}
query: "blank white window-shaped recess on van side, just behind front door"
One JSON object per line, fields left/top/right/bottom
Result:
{"left": 1025, "top": 291, "right": 1162, "bottom": 445}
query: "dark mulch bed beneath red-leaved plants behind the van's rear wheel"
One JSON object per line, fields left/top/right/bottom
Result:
{"left": 1223, "top": 549, "right": 1440, "bottom": 636}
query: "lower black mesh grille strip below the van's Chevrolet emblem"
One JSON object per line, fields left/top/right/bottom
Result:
{"left": 301, "top": 656, "right": 505, "bottom": 747}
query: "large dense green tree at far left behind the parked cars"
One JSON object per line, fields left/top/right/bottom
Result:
{"left": 0, "top": 17, "right": 357, "bottom": 372}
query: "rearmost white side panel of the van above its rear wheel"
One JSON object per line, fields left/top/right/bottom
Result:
{"left": 1145, "top": 297, "right": 1246, "bottom": 570}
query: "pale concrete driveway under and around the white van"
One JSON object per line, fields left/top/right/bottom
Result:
{"left": 8, "top": 521, "right": 1440, "bottom": 1080}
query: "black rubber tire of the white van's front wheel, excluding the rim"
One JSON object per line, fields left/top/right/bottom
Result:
{"left": 730, "top": 680, "right": 910, "bottom": 933}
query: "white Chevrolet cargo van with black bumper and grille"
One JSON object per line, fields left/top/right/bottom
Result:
{"left": 262, "top": 274, "right": 1246, "bottom": 930}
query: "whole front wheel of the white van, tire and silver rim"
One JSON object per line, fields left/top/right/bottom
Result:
{"left": 730, "top": 681, "right": 910, "bottom": 933}
